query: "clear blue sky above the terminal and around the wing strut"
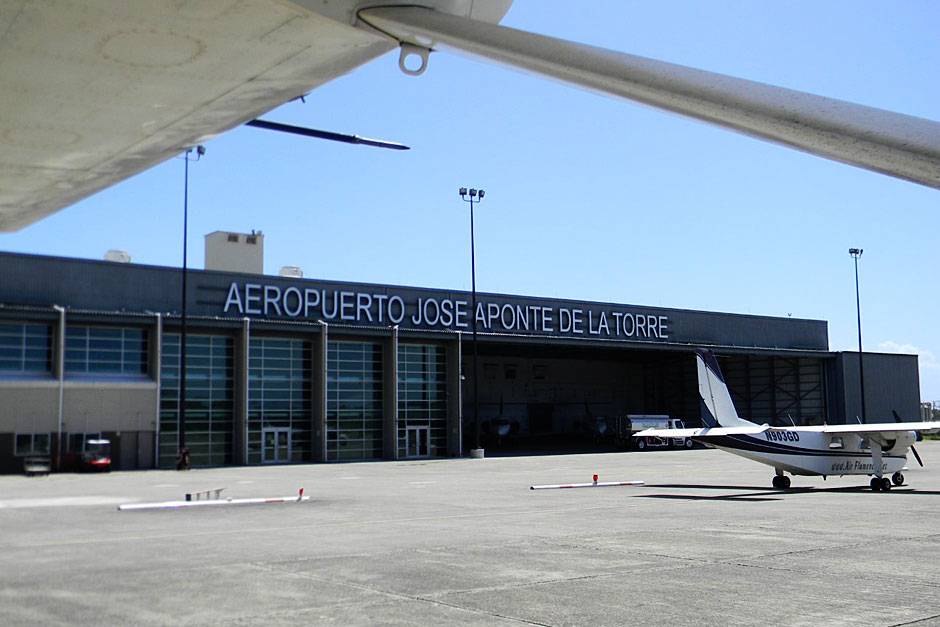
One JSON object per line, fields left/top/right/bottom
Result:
{"left": 0, "top": 0, "right": 940, "bottom": 400}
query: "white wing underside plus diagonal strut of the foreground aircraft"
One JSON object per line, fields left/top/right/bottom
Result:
{"left": 0, "top": 0, "right": 940, "bottom": 231}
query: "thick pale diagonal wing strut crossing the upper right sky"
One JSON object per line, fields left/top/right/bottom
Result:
{"left": 359, "top": 7, "right": 940, "bottom": 189}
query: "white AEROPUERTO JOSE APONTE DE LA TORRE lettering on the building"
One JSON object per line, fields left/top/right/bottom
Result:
{"left": 223, "top": 282, "right": 670, "bottom": 340}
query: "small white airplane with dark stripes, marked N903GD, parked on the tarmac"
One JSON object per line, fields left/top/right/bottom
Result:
{"left": 634, "top": 349, "right": 940, "bottom": 492}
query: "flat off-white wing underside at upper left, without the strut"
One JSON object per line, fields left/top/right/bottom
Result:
{"left": 0, "top": 0, "right": 395, "bottom": 231}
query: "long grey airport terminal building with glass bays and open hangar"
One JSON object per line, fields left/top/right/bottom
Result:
{"left": 0, "top": 248, "right": 919, "bottom": 472}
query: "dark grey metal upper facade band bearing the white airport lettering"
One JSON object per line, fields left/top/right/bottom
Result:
{"left": 0, "top": 253, "right": 828, "bottom": 351}
